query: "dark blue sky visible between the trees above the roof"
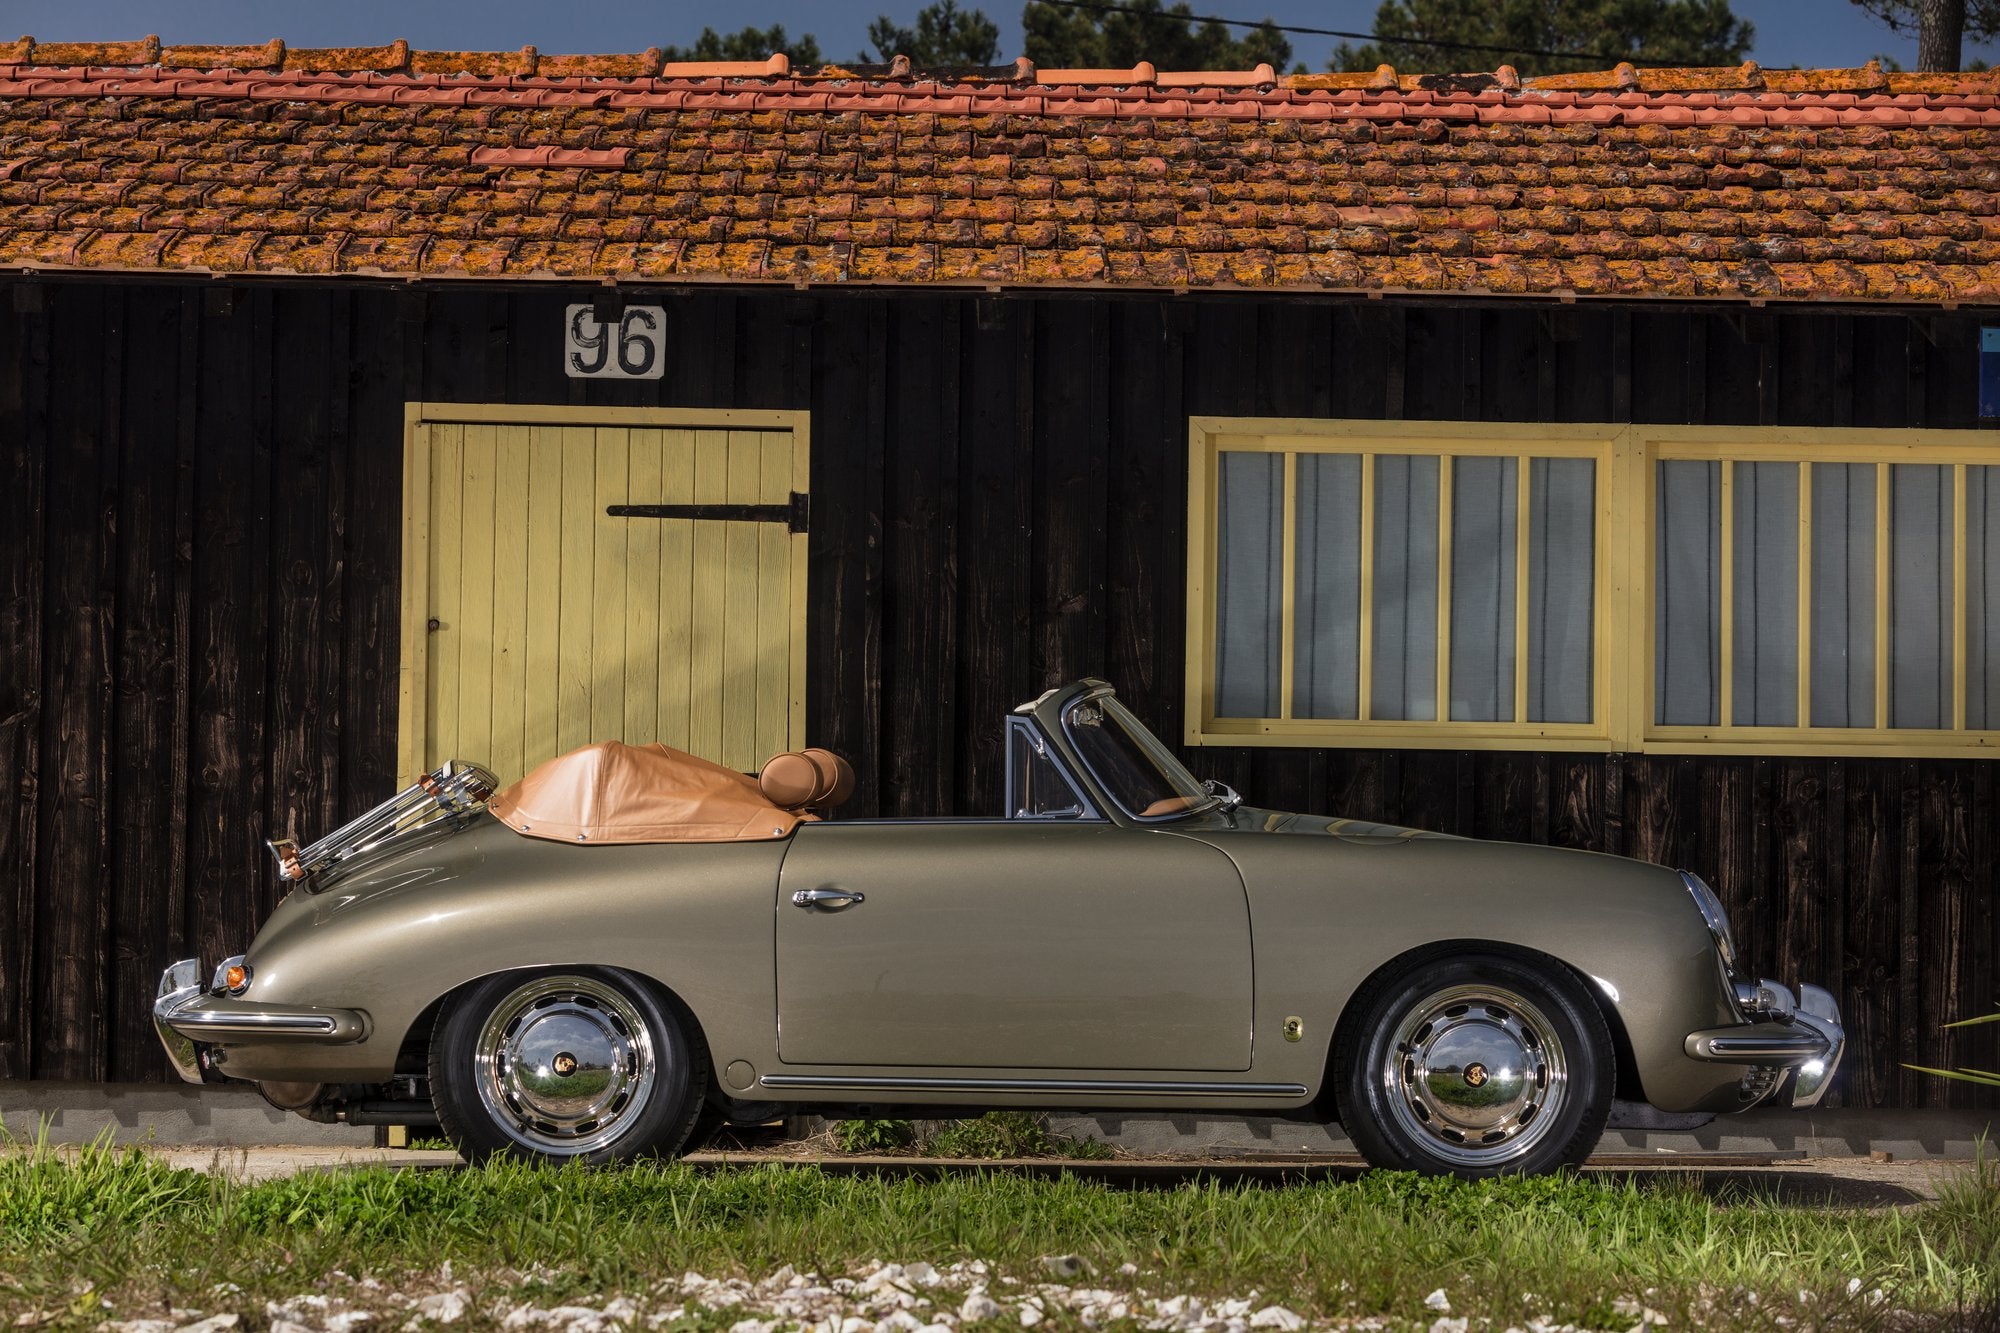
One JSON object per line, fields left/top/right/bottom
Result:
{"left": 0, "top": 0, "right": 2000, "bottom": 68}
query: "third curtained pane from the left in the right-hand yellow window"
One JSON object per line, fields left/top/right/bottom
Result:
{"left": 1812, "top": 462, "right": 1876, "bottom": 727}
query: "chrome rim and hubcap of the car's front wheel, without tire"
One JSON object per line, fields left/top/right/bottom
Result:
{"left": 1382, "top": 985, "right": 1570, "bottom": 1167}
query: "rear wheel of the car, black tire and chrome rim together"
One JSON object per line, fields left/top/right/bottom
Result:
{"left": 430, "top": 967, "right": 708, "bottom": 1165}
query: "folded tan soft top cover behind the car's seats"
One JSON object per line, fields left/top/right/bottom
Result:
{"left": 486, "top": 741, "right": 812, "bottom": 843}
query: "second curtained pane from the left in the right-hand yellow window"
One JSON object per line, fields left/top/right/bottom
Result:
{"left": 1730, "top": 462, "right": 1798, "bottom": 727}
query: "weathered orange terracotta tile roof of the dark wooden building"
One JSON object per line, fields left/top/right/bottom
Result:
{"left": 0, "top": 38, "right": 2000, "bottom": 302}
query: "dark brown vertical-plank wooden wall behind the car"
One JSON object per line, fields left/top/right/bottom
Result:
{"left": 0, "top": 278, "right": 2000, "bottom": 1107}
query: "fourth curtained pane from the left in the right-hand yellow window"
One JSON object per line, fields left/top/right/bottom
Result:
{"left": 1888, "top": 462, "right": 1952, "bottom": 727}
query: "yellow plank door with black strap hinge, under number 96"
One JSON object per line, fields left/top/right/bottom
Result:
{"left": 402, "top": 408, "right": 806, "bottom": 783}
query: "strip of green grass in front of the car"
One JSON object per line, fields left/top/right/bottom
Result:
{"left": 0, "top": 1147, "right": 2000, "bottom": 1333}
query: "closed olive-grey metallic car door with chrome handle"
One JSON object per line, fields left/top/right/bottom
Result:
{"left": 776, "top": 821, "right": 1252, "bottom": 1071}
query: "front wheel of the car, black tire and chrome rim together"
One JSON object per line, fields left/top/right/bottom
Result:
{"left": 1334, "top": 953, "right": 1616, "bottom": 1179}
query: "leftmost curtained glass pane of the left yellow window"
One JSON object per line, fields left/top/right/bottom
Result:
{"left": 1216, "top": 452, "right": 1284, "bottom": 717}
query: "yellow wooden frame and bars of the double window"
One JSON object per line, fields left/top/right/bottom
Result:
{"left": 1184, "top": 416, "right": 2000, "bottom": 757}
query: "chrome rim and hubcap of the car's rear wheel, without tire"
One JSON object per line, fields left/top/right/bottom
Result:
{"left": 472, "top": 964, "right": 658, "bottom": 1157}
